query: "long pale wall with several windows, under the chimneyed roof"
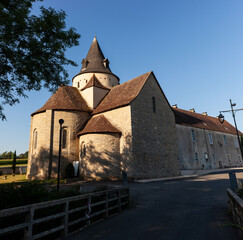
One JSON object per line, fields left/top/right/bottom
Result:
{"left": 176, "top": 124, "right": 242, "bottom": 170}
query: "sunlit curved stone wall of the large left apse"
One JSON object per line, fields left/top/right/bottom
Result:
{"left": 27, "top": 110, "right": 90, "bottom": 178}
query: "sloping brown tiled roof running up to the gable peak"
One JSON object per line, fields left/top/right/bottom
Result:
{"left": 92, "top": 72, "right": 152, "bottom": 114}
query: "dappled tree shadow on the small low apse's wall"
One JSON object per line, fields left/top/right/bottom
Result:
{"left": 80, "top": 135, "right": 133, "bottom": 180}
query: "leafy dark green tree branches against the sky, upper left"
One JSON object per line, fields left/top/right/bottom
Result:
{"left": 0, "top": 0, "right": 80, "bottom": 120}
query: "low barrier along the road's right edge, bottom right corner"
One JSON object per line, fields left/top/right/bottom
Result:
{"left": 227, "top": 188, "right": 243, "bottom": 228}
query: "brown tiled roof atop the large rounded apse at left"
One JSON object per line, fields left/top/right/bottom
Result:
{"left": 31, "top": 86, "right": 92, "bottom": 116}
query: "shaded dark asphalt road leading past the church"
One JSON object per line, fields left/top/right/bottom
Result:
{"left": 68, "top": 173, "right": 243, "bottom": 240}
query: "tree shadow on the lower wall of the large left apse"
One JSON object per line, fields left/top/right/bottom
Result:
{"left": 27, "top": 148, "right": 73, "bottom": 179}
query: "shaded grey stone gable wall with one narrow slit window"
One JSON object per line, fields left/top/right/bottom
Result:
{"left": 131, "top": 74, "right": 180, "bottom": 178}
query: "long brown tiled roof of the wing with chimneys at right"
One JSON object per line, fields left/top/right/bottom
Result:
{"left": 172, "top": 108, "right": 239, "bottom": 135}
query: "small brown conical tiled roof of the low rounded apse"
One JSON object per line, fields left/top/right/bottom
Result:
{"left": 78, "top": 115, "right": 121, "bottom": 135}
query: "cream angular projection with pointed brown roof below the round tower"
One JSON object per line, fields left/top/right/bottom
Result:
{"left": 81, "top": 74, "right": 110, "bottom": 109}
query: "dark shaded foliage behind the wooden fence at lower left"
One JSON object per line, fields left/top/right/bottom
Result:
{"left": 0, "top": 181, "right": 80, "bottom": 209}
